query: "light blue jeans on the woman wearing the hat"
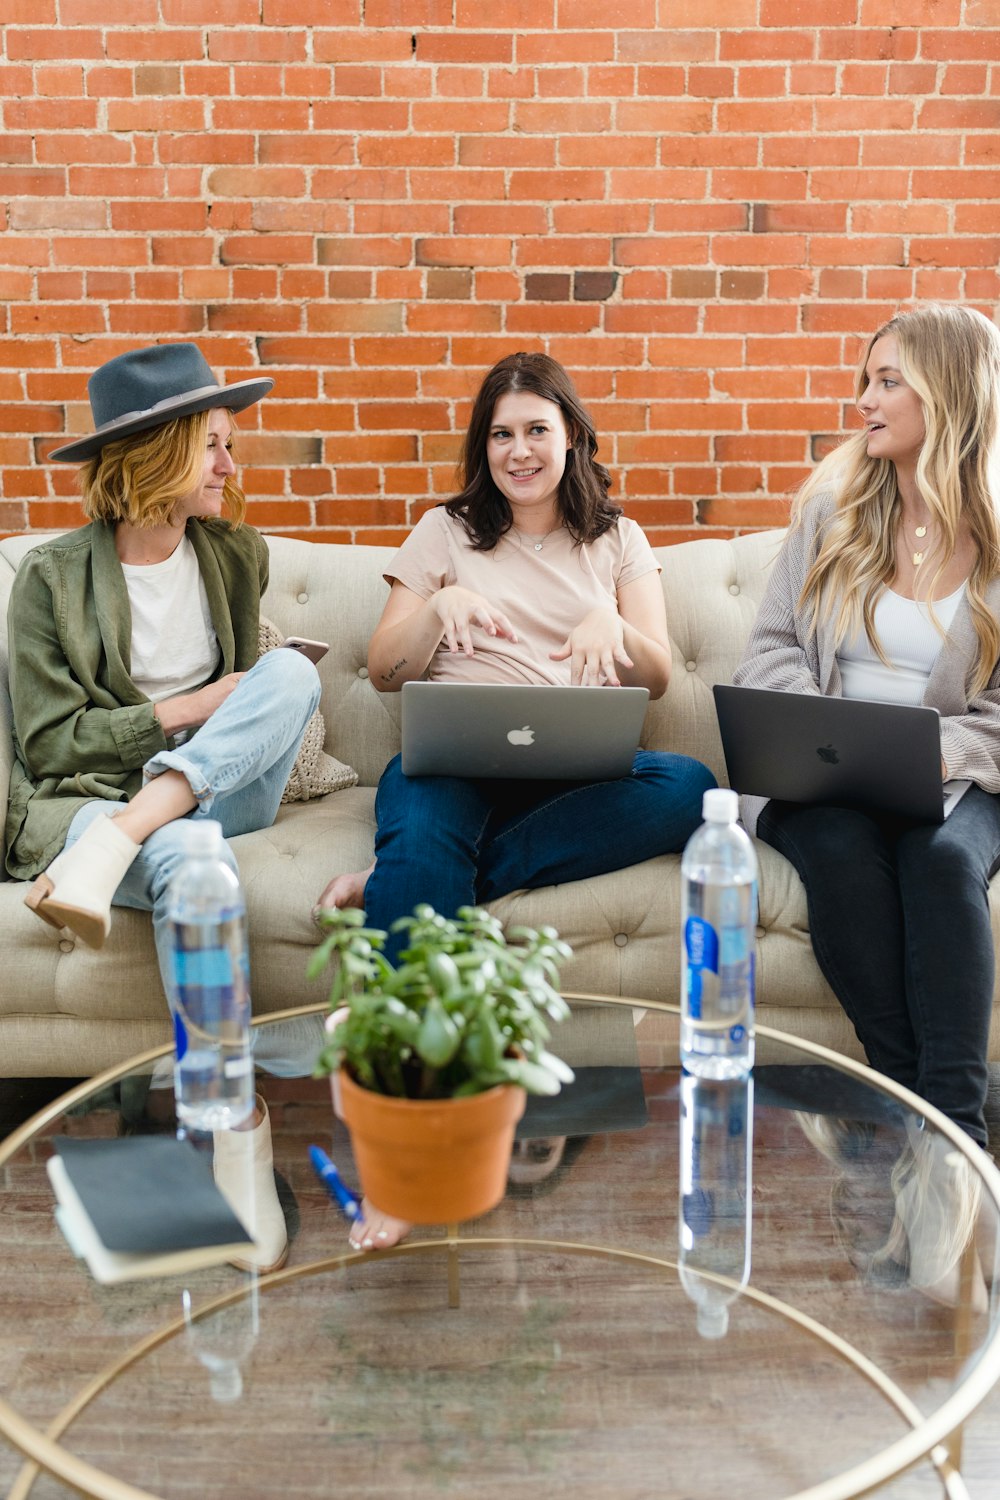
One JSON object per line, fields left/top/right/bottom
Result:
{"left": 64, "top": 651, "right": 319, "bottom": 995}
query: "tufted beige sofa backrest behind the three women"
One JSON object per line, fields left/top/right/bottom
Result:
{"left": 0, "top": 531, "right": 783, "bottom": 806}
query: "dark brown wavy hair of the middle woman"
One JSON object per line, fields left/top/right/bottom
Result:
{"left": 445, "top": 354, "right": 622, "bottom": 552}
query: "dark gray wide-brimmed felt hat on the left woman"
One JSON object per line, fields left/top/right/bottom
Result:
{"left": 49, "top": 344, "right": 274, "bottom": 464}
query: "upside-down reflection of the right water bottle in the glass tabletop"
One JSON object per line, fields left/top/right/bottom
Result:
{"left": 678, "top": 1073, "right": 754, "bottom": 1338}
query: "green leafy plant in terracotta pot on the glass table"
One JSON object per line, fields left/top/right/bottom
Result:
{"left": 309, "top": 906, "right": 573, "bottom": 1224}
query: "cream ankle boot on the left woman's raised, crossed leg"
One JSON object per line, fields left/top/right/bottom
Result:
{"left": 24, "top": 815, "right": 139, "bottom": 948}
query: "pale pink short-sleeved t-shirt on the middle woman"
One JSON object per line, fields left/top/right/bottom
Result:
{"left": 385, "top": 506, "right": 660, "bottom": 687}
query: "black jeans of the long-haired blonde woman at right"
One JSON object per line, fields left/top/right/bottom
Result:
{"left": 757, "top": 786, "right": 1000, "bottom": 1146}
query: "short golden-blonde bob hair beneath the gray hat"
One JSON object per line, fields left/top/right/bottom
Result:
{"left": 79, "top": 411, "right": 246, "bottom": 527}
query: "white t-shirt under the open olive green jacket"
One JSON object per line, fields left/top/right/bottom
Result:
{"left": 121, "top": 537, "right": 219, "bottom": 704}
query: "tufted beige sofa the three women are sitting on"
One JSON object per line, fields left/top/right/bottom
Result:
{"left": 0, "top": 533, "right": 1000, "bottom": 1077}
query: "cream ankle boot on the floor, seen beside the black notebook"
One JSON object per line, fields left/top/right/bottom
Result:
{"left": 213, "top": 1094, "right": 288, "bottom": 1275}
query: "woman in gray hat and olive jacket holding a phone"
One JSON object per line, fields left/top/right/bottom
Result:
{"left": 6, "top": 344, "right": 319, "bottom": 1268}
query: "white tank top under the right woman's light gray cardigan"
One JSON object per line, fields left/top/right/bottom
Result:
{"left": 837, "top": 584, "right": 966, "bottom": 704}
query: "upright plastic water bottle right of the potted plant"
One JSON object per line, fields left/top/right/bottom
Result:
{"left": 681, "top": 788, "right": 757, "bottom": 1079}
